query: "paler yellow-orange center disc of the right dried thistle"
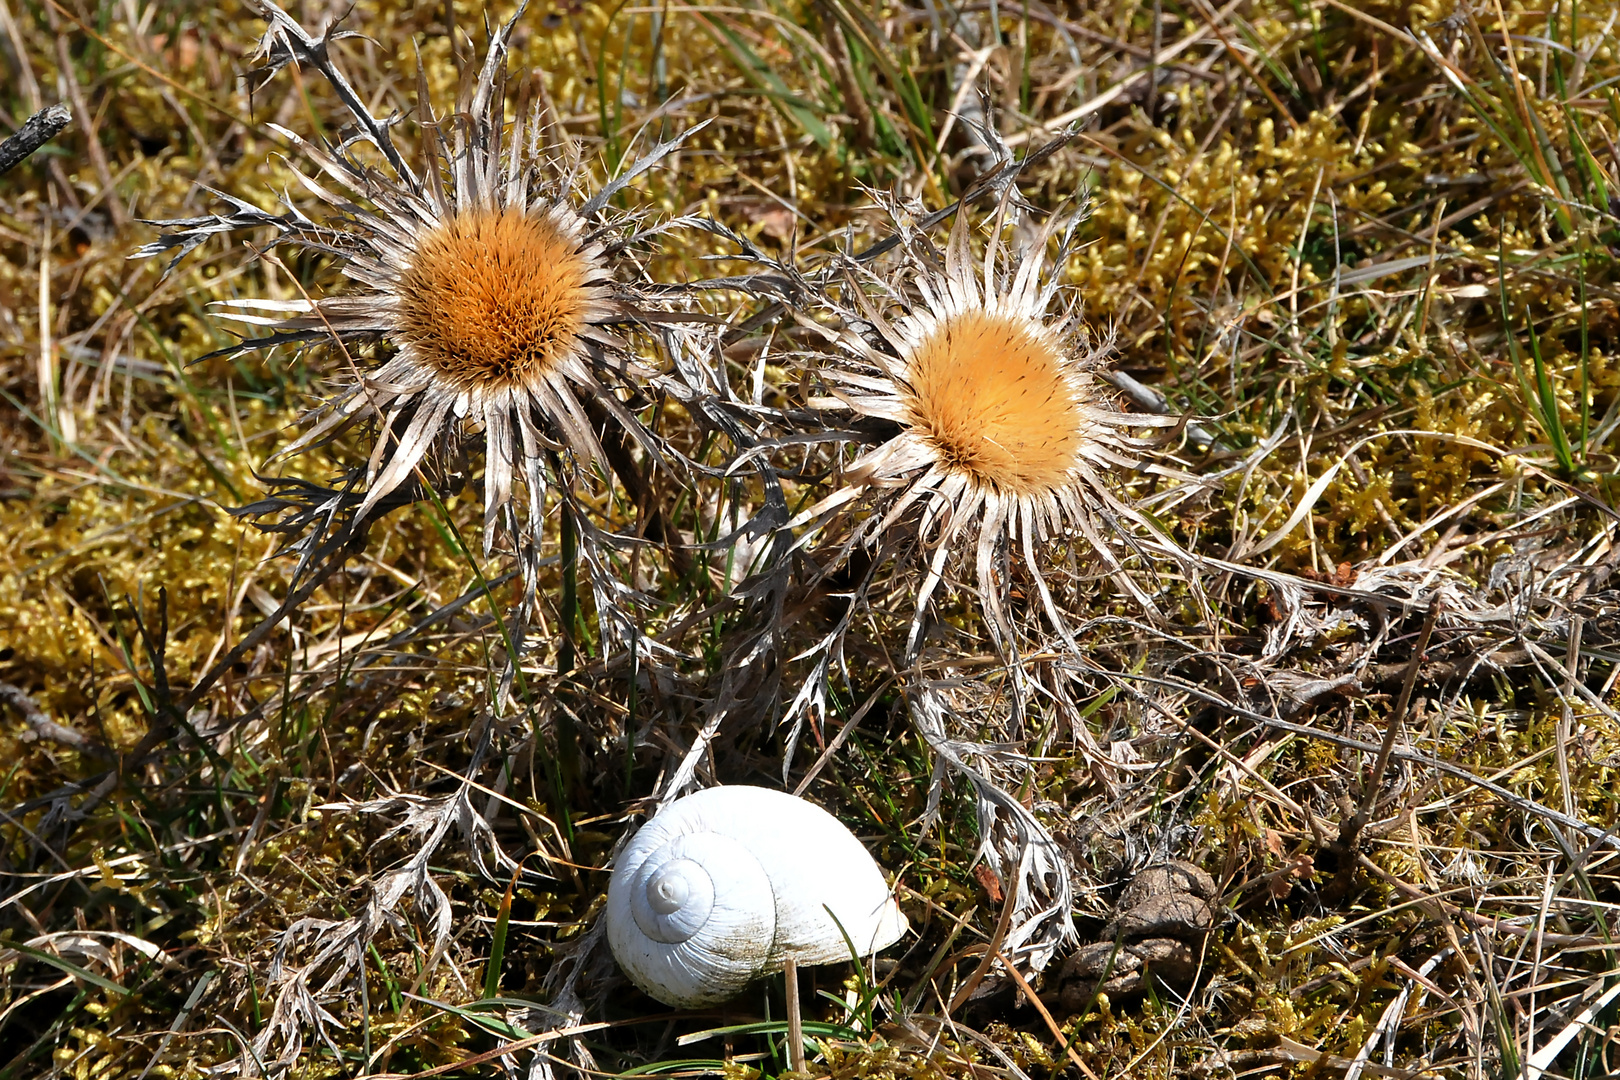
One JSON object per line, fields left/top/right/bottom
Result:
{"left": 906, "top": 313, "right": 1085, "bottom": 495}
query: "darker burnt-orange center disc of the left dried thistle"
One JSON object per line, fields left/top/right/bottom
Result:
{"left": 399, "top": 210, "right": 593, "bottom": 390}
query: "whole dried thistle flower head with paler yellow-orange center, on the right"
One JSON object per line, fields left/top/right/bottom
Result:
{"left": 797, "top": 199, "right": 1179, "bottom": 649}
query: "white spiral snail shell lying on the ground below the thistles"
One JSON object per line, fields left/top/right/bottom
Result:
{"left": 606, "top": 785, "right": 906, "bottom": 1009}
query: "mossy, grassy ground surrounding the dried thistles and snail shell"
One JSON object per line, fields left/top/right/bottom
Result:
{"left": 0, "top": 0, "right": 1620, "bottom": 1078}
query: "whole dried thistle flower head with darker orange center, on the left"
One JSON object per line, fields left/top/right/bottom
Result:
{"left": 141, "top": 0, "right": 709, "bottom": 554}
